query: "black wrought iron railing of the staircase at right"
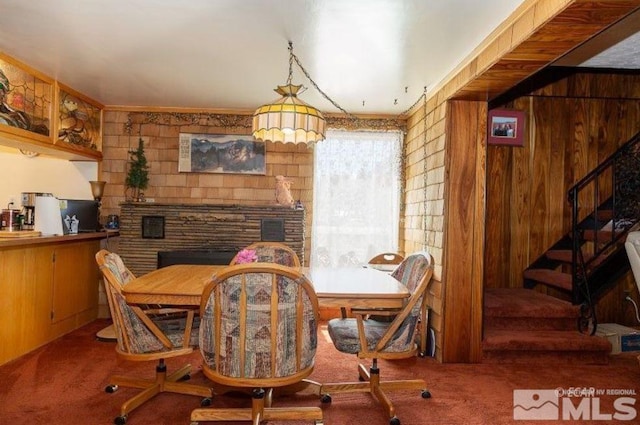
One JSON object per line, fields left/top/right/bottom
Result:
{"left": 568, "top": 133, "right": 640, "bottom": 333}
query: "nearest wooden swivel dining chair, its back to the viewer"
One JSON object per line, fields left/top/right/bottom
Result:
{"left": 191, "top": 263, "right": 322, "bottom": 425}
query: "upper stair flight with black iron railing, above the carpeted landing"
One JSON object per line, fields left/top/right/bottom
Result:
{"left": 523, "top": 133, "right": 640, "bottom": 335}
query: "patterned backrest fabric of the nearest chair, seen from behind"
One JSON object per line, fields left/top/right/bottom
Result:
{"left": 200, "top": 272, "right": 318, "bottom": 380}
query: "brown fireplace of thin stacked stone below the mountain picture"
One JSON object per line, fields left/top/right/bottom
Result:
{"left": 118, "top": 202, "right": 305, "bottom": 276}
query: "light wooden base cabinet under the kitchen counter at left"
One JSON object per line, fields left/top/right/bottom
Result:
{"left": 0, "top": 239, "right": 100, "bottom": 364}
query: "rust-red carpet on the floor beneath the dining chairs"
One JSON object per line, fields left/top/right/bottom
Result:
{"left": 0, "top": 320, "right": 640, "bottom": 425}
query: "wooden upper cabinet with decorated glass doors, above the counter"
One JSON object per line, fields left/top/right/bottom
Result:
{"left": 0, "top": 52, "right": 103, "bottom": 161}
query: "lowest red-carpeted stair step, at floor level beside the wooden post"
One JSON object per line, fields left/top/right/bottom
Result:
{"left": 482, "top": 329, "right": 611, "bottom": 364}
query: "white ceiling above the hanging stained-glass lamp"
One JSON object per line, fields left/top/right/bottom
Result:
{"left": 0, "top": 0, "right": 523, "bottom": 114}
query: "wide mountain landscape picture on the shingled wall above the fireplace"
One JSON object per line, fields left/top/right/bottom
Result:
{"left": 178, "top": 133, "right": 266, "bottom": 175}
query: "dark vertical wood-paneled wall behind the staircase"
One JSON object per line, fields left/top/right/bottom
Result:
{"left": 485, "top": 73, "right": 640, "bottom": 322}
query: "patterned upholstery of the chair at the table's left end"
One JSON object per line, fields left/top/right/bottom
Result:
{"left": 105, "top": 253, "right": 199, "bottom": 354}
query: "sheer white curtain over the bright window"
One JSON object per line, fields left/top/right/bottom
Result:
{"left": 311, "top": 131, "right": 402, "bottom": 267}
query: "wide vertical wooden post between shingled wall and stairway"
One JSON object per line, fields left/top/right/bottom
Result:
{"left": 443, "top": 101, "right": 487, "bottom": 363}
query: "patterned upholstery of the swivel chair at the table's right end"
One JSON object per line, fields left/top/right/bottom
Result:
{"left": 328, "top": 253, "right": 431, "bottom": 354}
